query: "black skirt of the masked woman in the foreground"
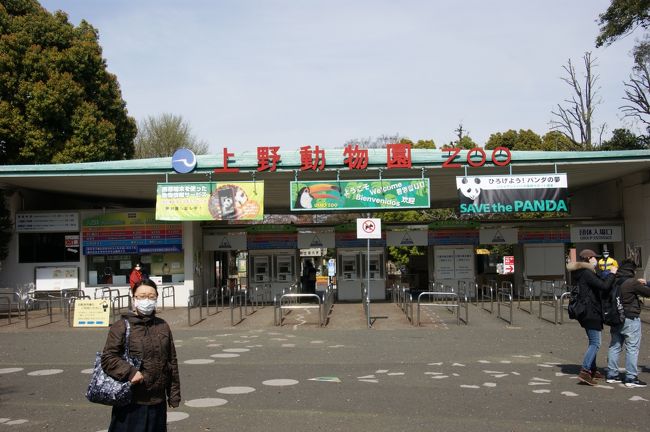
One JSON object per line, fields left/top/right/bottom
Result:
{"left": 108, "top": 402, "right": 167, "bottom": 432}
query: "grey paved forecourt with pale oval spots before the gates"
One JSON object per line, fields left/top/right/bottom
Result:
{"left": 0, "top": 303, "right": 650, "bottom": 432}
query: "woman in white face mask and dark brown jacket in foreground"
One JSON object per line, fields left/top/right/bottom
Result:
{"left": 102, "top": 279, "right": 181, "bottom": 432}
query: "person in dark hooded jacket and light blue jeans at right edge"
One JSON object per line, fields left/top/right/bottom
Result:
{"left": 607, "top": 259, "right": 650, "bottom": 388}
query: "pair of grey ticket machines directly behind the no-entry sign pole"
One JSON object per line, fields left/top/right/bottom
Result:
{"left": 337, "top": 247, "right": 386, "bottom": 301}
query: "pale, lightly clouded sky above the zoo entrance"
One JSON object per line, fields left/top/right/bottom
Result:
{"left": 41, "top": 0, "right": 639, "bottom": 153}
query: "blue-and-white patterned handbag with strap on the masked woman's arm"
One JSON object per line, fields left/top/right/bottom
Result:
{"left": 86, "top": 320, "right": 142, "bottom": 406}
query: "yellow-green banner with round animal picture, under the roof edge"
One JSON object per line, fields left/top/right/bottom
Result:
{"left": 156, "top": 181, "right": 264, "bottom": 221}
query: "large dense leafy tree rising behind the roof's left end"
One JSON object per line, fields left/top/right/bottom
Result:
{"left": 0, "top": 0, "right": 136, "bottom": 164}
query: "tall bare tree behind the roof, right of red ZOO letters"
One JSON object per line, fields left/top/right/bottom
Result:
{"left": 551, "top": 52, "right": 606, "bottom": 150}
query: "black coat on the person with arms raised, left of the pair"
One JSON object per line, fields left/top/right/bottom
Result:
{"left": 566, "top": 262, "right": 614, "bottom": 330}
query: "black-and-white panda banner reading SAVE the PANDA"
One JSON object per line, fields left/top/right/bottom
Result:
{"left": 456, "top": 173, "right": 569, "bottom": 215}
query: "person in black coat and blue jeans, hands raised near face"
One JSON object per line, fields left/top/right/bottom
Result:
{"left": 567, "top": 249, "right": 618, "bottom": 385}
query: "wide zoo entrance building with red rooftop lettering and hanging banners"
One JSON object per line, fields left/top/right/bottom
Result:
{"left": 0, "top": 145, "right": 650, "bottom": 314}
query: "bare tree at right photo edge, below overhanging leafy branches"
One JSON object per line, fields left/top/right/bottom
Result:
{"left": 620, "top": 57, "right": 650, "bottom": 130}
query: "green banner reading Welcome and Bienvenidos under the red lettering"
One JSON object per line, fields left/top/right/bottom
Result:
{"left": 290, "top": 178, "right": 430, "bottom": 212}
